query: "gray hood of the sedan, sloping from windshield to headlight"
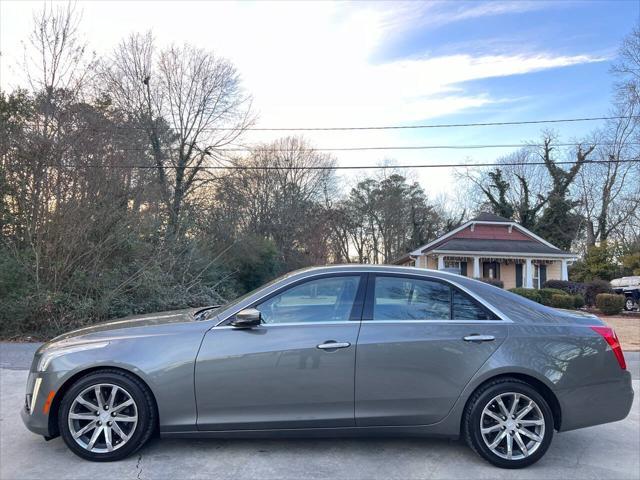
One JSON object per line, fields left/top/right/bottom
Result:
{"left": 48, "top": 308, "right": 198, "bottom": 344}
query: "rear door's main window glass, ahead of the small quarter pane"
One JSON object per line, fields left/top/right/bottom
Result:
{"left": 373, "top": 276, "right": 451, "bottom": 320}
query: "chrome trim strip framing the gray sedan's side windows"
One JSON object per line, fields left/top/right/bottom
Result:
{"left": 211, "top": 268, "right": 514, "bottom": 328}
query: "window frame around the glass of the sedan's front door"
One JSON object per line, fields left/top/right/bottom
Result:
{"left": 213, "top": 272, "right": 370, "bottom": 329}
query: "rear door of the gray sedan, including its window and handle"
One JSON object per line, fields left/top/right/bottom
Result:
{"left": 355, "top": 274, "right": 507, "bottom": 426}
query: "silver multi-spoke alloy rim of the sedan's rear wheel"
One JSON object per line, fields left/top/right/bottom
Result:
{"left": 480, "top": 392, "right": 545, "bottom": 460}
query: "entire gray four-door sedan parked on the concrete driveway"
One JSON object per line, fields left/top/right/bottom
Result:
{"left": 22, "top": 265, "right": 633, "bottom": 468}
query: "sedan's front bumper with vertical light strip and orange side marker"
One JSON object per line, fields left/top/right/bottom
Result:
{"left": 20, "top": 372, "right": 60, "bottom": 437}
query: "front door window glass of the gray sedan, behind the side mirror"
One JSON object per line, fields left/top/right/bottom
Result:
{"left": 255, "top": 275, "right": 360, "bottom": 324}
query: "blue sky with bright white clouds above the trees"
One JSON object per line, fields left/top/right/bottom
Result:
{"left": 0, "top": 0, "right": 640, "bottom": 197}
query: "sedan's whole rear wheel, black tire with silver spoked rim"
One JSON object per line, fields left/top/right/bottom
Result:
{"left": 464, "top": 379, "right": 554, "bottom": 468}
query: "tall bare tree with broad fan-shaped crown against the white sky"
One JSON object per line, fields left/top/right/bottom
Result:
{"left": 101, "top": 34, "right": 253, "bottom": 235}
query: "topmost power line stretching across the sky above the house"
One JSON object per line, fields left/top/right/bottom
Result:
{"left": 25, "top": 115, "right": 640, "bottom": 132}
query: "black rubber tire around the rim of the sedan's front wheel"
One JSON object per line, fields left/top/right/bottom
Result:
{"left": 58, "top": 369, "right": 158, "bottom": 462}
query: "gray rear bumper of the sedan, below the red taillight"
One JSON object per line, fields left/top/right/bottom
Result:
{"left": 556, "top": 371, "right": 633, "bottom": 432}
